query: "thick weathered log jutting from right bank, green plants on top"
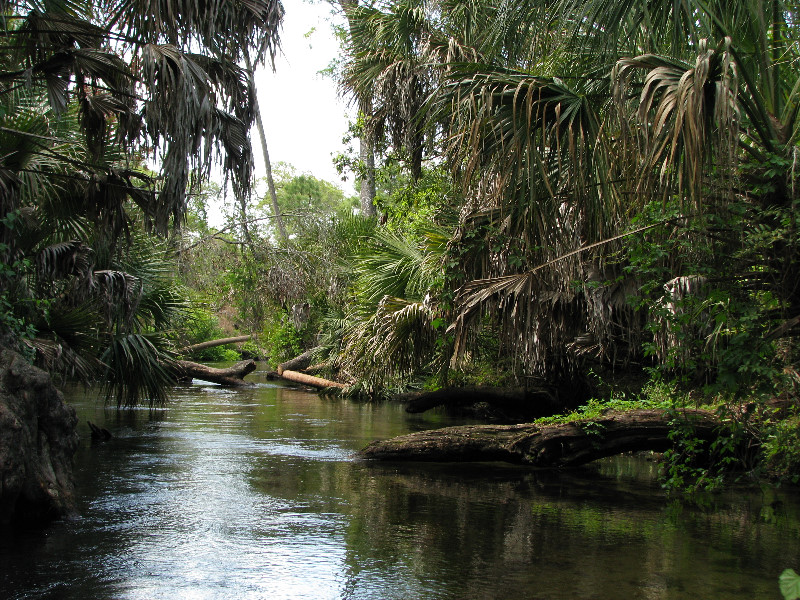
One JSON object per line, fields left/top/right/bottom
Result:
{"left": 359, "top": 410, "right": 720, "bottom": 468}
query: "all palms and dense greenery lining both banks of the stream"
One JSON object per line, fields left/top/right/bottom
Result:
{"left": 0, "top": 0, "right": 800, "bottom": 488}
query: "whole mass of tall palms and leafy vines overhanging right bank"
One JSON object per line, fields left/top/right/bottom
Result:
{"left": 343, "top": 0, "right": 800, "bottom": 392}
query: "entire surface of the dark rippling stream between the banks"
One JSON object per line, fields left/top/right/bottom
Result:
{"left": 0, "top": 374, "right": 800, "bottom": 600}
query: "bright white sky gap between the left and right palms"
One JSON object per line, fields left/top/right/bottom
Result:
{"left": 251, "top": 0, "right": 353, "bottom": 194}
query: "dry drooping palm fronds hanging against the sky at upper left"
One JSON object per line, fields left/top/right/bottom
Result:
{"left": 2, "top": 0, "right": 283, "bottom": 231}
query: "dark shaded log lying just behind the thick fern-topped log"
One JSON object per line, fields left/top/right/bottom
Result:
{"left": 394, "top": 387, "right": 564, "bottom": 419}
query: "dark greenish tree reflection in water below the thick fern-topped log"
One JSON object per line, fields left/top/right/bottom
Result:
{"left": 338, "top": 464, "right": 798, "bottom": 598}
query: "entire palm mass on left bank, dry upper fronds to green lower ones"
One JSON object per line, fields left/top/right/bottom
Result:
{"left": 0, "top": 0, "right": 283, "bottom": 404}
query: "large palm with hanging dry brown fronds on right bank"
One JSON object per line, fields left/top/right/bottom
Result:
{"left": 433, "top": 0, "right": 800, "bottom": 390}
